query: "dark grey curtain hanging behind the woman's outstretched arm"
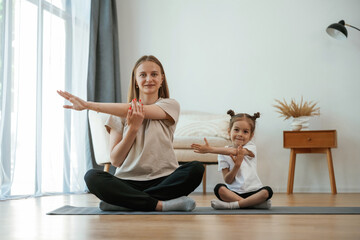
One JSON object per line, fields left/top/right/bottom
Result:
{"left": 87, "top": 0, "right": 121, "bottom": 168}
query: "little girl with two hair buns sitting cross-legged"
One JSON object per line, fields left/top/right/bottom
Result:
{"left": 191, "top": 110, "right": 273, "bottom": 209}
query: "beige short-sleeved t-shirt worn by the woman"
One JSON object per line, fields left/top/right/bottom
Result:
{"left": 105, "top": 98, "right": 180, "bottom": 181}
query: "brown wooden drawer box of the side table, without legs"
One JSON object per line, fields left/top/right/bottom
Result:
{"left": 284, "top": 130, "right": 337, "bottom": 148}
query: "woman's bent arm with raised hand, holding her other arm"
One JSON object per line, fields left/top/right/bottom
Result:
{"left": 110, "top": 100, "right": 144, "bottom": 167}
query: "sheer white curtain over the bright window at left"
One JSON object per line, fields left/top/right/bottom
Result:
{"left": 0, "top": 0, "right": 91, "bottom": 199}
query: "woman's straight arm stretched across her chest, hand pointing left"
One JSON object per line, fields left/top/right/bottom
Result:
{"left": 57, "top": 90, "right": 174, "bottom": 122}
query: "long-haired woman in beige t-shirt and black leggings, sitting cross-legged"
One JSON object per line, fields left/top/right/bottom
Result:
{"left": 58, "top": 56, "right": 204, "bottom": 211}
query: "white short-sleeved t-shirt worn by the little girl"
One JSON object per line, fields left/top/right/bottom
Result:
{"left": 218, "top": 141, "right": 263, "bottom": 194}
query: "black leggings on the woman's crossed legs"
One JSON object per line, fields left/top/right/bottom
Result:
{"left": 84, "top": 161, "right": 204, "bottom": 211}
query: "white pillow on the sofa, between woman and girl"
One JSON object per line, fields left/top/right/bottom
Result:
{"left": 174, "top": 111, "right": 230, "bottom": 139}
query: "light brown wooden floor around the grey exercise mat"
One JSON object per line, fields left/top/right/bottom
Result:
{"left": 0, "top": 193, "right": 360, "bottom": 240}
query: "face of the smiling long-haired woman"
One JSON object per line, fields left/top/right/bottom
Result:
{"left": 136, "top": 61, "right": 163, "bottom": 96}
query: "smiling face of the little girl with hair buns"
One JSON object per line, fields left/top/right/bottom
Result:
{"left": 229, "top": 120, "right": 253, "bottom": 147}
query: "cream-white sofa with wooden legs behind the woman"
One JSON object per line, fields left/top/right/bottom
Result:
{"left": 89, "top": 111, "right": 230, "bottom": 193}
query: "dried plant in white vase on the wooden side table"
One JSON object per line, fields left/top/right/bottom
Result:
{"left": 273, "top": 97, "right": 320, "bottom": 131}
